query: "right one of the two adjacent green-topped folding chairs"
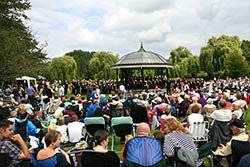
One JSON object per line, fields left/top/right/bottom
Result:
{"left": 111, "top": 117, "right": 134, "bottom": 151}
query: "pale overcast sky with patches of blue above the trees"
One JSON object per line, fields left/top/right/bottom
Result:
{"left": 28, "top": 0, "right": 250, "bottom": 58}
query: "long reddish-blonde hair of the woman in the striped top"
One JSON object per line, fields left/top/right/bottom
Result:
{"left": 164, "top": 118, "right": 189, "bottom": 134}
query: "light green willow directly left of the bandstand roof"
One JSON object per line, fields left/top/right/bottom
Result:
{"left": 89, "top": 52, "right": 118, "bottom": 79}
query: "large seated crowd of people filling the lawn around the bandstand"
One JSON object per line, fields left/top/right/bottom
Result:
{"left": 0, "top": 78, "right": 250, "bottom": 167}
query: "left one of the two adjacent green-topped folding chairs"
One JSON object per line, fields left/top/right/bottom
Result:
{"left": 84, "top": 117, "right": 105, "bottom": 141}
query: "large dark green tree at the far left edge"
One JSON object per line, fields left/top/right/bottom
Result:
{"left": 0, "top": 0, "right": 46, "bottom": 80}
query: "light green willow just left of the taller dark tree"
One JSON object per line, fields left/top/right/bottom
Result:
{"left": 46, "top": 55, "right": 77, "bottom": 81}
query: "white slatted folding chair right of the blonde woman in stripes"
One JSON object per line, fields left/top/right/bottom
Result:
{"left": 190, "top": 121, "right": 209, "bottom": 142}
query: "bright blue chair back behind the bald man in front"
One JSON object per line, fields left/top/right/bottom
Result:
{"left": 124, "top": 136, "right": 163, "bottom": 167}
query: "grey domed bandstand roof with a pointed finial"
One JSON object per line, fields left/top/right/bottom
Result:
{"left": 111, "top": 43, "right": 173, "bottom": 69}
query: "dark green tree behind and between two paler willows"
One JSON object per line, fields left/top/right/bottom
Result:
{"left": 66, "top": 50, "right": 95, "bottom": 79}
